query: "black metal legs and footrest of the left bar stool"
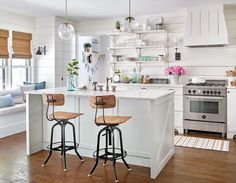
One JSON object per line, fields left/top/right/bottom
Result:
{"left": 42, "top": 120, "right": 84, "bottom": 171}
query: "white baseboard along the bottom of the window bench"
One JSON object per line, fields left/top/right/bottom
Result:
{"left": 0, "top": 120, "right": 26, "bottom": 138}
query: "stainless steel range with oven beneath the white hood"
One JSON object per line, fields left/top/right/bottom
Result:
{"left": 184, "top": 80, "right": 227, "bottom": 137}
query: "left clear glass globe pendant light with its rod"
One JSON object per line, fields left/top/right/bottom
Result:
{"left": 58, "top": 0, "right": 75, "bottom": 40}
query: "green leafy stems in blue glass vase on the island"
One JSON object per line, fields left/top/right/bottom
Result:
{"left": 67, "top": 59, "right": 79, "bottom": 91}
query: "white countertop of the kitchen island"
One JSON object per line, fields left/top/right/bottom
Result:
{"left": 26, "top": 87, "right": 174, "bottom": 100}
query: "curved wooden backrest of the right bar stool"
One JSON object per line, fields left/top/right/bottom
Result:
{"left": 89, "top": 95, "right": 116, "bottom": 109}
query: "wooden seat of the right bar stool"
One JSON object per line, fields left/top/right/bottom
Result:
{"left": 96, "top": 116, "right": 131, "bottom": 125}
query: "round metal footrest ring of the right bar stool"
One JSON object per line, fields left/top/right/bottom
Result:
{"left": 93, "top": 148, "right": 127, "bottom": 161}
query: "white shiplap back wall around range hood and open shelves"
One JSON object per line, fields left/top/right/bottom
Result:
{"left": 77, "top": 6, "right": 236, "bottom": 82}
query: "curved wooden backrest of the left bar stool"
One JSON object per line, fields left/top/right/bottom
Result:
{"left": 43, "top": 93, "right": 65, "bottom": 106}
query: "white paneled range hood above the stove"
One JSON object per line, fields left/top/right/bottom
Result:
{"left": 184, "top": 5, "right": 228, "bottom": 47}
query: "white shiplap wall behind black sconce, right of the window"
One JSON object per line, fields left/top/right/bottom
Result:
{"left": 36, "top": 16, "right": 75, "bottom": 87}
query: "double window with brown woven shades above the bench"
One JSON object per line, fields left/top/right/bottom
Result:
{"left": 0, "top": 29, "right": 32, "bottom": 90}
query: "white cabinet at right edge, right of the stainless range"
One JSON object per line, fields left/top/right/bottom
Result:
{"left": 227, "top": 88, "right": 236, "bottom": 138}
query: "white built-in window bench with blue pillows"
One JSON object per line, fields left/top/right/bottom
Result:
{"left": 0, "top": 81, "right": 46, "bottom": 138}
